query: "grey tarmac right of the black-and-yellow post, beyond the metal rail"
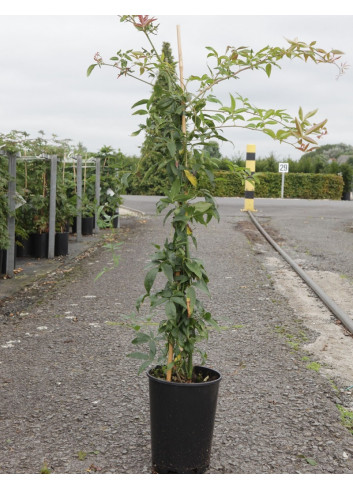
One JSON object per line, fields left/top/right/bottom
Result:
{"left": 255, "top": 201, "right": 353, "bottom": 279}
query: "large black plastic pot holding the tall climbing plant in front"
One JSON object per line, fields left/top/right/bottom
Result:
{"left": 147, "top": 367, "right": 221, "bottom": 474}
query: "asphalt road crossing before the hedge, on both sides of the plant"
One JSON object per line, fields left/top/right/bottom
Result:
{"left": 124, "top": 195, "right": 353, "bottom": 280}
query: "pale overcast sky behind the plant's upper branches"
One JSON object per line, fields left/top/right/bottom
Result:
{"left": 0, "top": 2, "right": 353, "bottom": 161}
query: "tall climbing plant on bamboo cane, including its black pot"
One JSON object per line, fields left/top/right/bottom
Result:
{"left": 87, "top": 15, "right": 344, "bottom": 473}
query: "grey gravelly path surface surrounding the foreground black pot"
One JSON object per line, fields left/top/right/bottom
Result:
{"left": 0, "top": 216, "right": 353, "bottom": 474}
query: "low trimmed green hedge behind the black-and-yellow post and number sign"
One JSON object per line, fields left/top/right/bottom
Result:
{"left": 199, "top": 171, "right": 344, "bottom": 200}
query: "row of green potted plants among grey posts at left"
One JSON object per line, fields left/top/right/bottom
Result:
{"left": 0, "top": 131, "right": 126, "bottom": 266}
